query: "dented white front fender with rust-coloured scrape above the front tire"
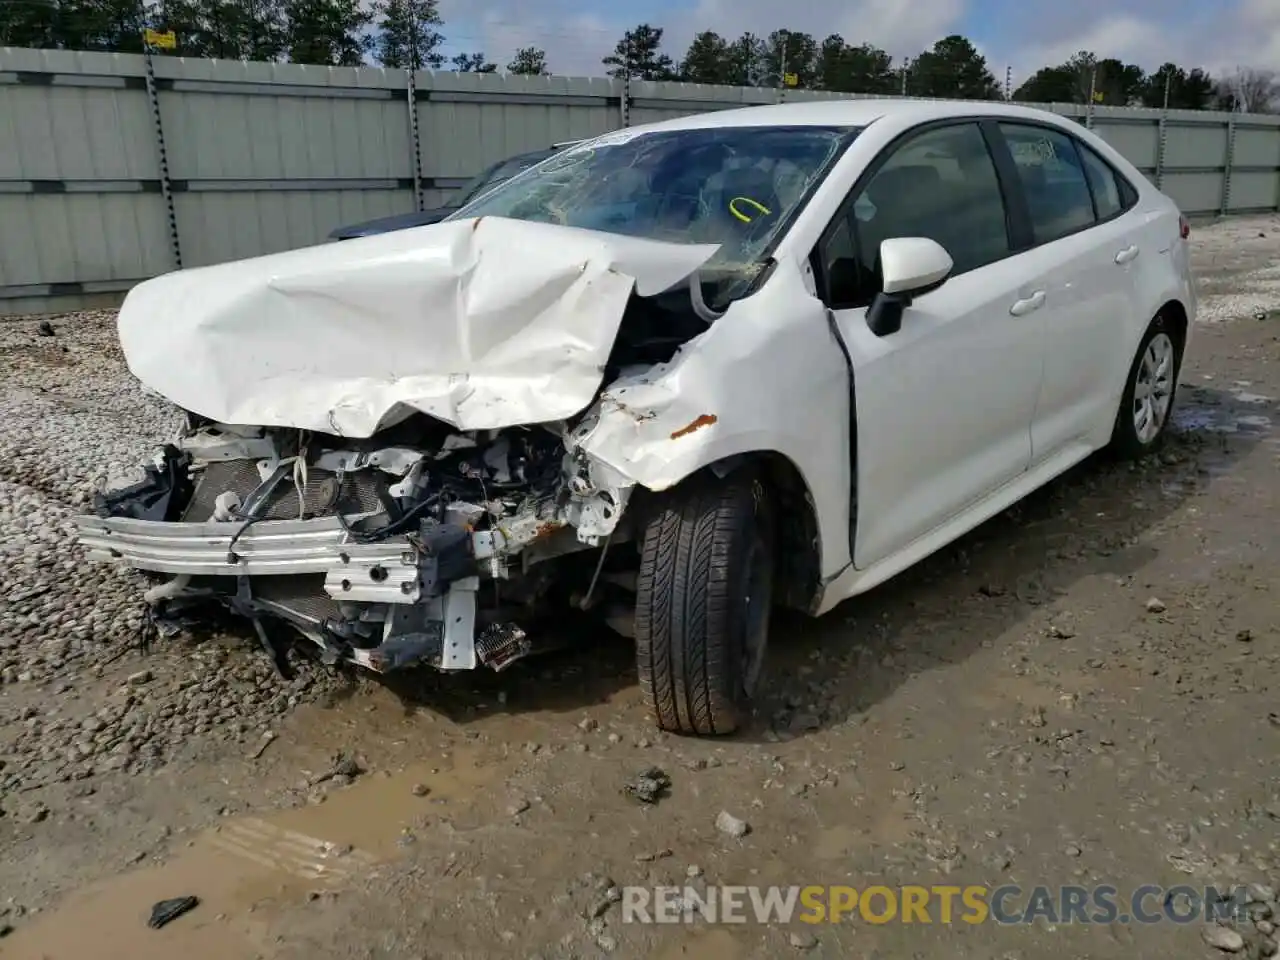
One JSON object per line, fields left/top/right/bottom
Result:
{"left": 566, "top": 259, "right": 851, "bottom": 576}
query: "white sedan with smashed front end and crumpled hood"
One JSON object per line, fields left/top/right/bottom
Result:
{"left": 78, "top": 100, "right": 1196, "bottom": 733}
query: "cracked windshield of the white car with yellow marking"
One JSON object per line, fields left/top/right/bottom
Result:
{"left": 449, "top": 125, "right": 856, "bottom": 273}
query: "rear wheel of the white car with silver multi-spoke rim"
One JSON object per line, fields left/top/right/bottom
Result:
{"left": 1111, "top": 315, "right": 1183, "bottom": 460}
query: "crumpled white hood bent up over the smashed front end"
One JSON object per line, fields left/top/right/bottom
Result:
{"left": 119, "top": 218, "right": 717, "bottom": 436}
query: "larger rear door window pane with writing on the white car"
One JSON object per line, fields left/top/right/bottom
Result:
{"left": 1000, "top": 123, "right": 1095, "bottom": 243}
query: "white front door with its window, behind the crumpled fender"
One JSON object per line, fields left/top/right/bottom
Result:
{"left": 819, "top": 122, "right": 1044, "bottom": 568}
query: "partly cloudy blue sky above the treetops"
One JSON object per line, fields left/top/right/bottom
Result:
{"left": 440, "top": 0, "right": 1280, "bottom": 83}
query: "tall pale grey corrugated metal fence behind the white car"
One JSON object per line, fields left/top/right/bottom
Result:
{"left": 0, "top": 49, "right": 1280, "bottom": 315}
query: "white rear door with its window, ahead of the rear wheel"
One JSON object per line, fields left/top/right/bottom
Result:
{"left": 996, "top": 120, "right": 1156, "bottom": 463}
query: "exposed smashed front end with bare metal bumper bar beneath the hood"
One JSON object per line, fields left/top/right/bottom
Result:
{"left": 77, "top": 415, "right": 630, "bottom": 672}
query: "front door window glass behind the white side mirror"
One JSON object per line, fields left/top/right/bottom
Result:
{"left": 819, "top": 123, "right": 1012, "bottom": 308}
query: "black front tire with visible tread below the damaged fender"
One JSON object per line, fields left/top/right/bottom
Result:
{"left": 635, "top": 471, "right": 773, "bottom": 736}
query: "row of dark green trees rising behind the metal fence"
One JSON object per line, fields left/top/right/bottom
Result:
{"left": 0, "top": 0, "right": 1280, "bottom": 113}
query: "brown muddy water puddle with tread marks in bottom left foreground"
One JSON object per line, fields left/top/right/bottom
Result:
{"left": 0, "top": 753, "right": 499, "bottom": 960}
